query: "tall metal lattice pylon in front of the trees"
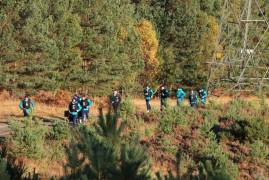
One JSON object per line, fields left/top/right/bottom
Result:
{"left": 207, "top": 0, "right": 269, "bottom": 91}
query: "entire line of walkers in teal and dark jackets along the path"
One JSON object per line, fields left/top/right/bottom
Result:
{"left": 19, "top": 86, "right": 208, "bottom": 125}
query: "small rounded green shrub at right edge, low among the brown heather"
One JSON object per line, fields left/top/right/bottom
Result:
{"left": 251, "top": 140, "right": 269, "bottom": 159}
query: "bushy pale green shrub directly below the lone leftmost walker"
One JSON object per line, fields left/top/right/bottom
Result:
{"left": 9, "top": 119, "right": 48, "bottom": 159}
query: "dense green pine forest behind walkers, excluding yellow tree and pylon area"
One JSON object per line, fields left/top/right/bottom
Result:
{"left": 0, "top": 0, "right": 227, "bottom": 95}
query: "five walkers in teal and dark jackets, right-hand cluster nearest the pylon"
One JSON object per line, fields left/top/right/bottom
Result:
{"left": 144, "top": 86, "right": 208, "bottom": 112}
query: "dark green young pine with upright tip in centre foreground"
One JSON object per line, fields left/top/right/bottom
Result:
{"left": 64, "top": 111, "right": 150, "bottom": 180}
